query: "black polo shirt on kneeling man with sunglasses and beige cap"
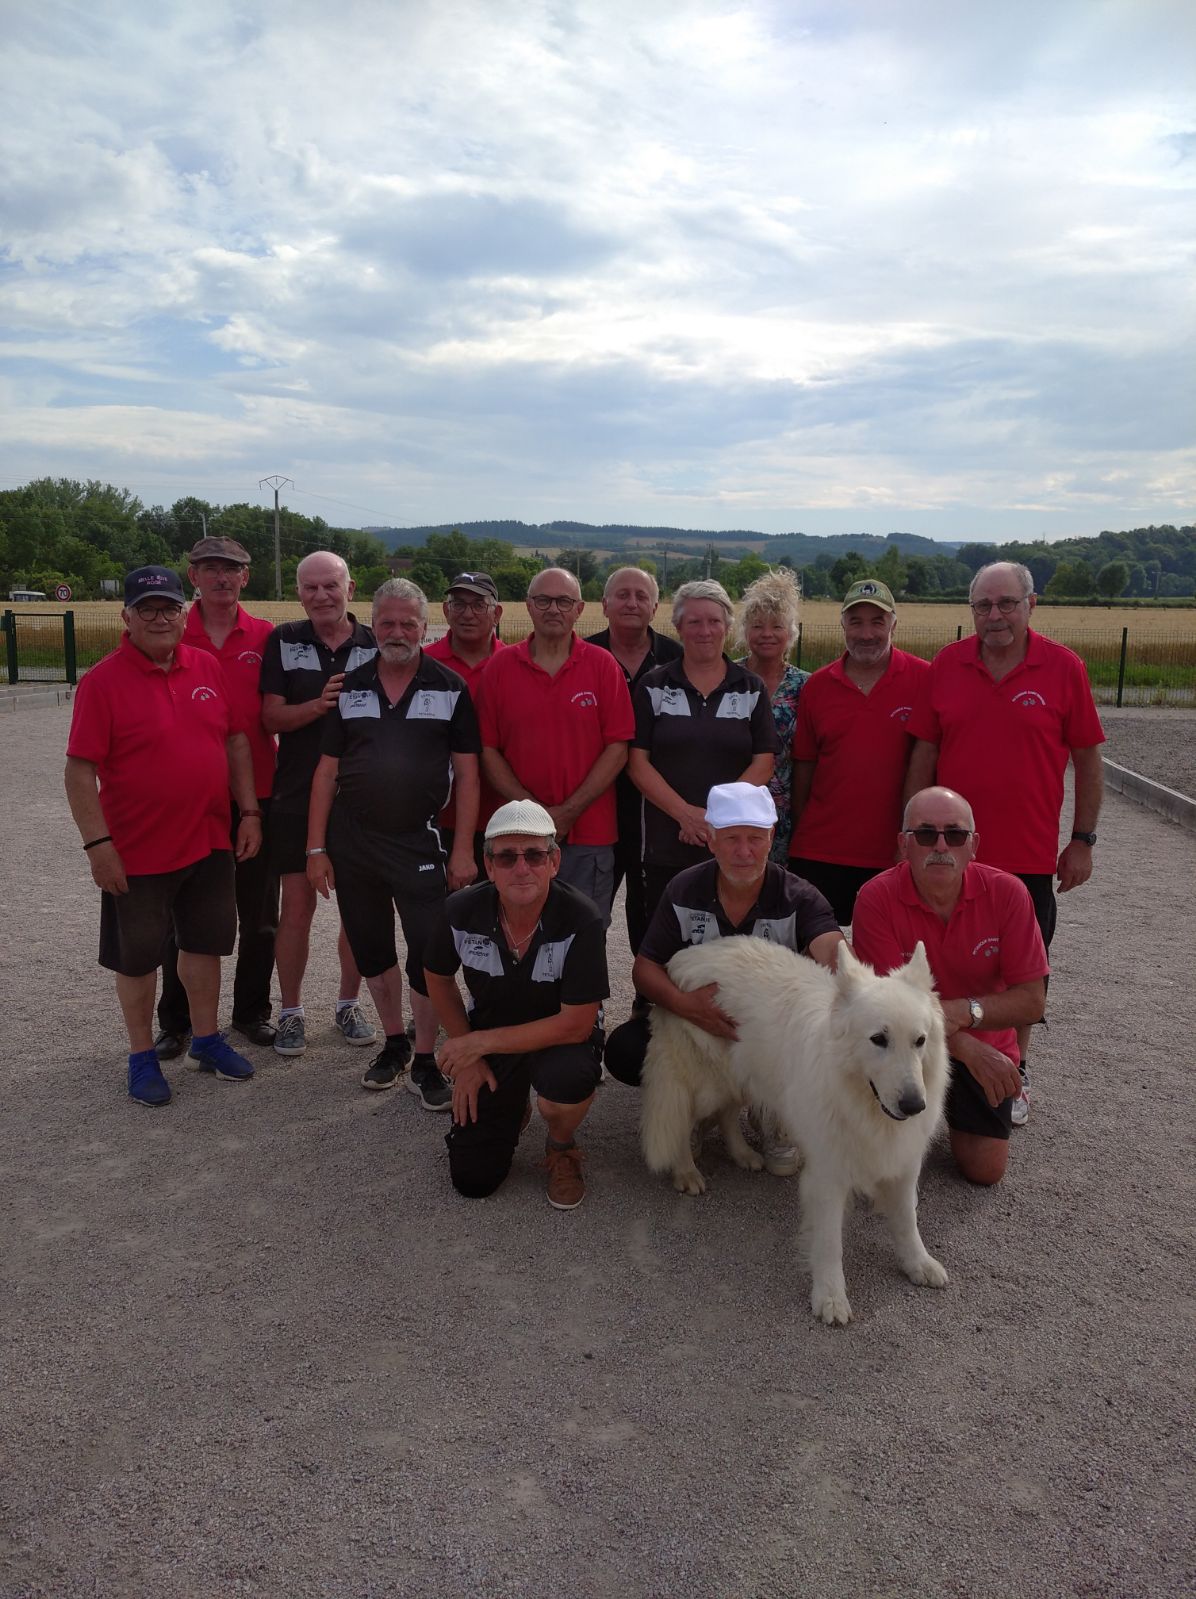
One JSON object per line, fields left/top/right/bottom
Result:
{"left": 424, "top": 878, "right": 611, "bottom": 1028}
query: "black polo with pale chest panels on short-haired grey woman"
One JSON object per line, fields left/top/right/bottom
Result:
{"left": 632, "top": 656, "right": 780, "bottom": 870}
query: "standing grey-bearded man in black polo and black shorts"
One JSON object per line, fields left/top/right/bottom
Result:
{"left": 307, "top": 577, "right": 481, "bottom": 1110}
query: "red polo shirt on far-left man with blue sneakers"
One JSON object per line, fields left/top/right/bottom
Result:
{"left": 67, "top": 633, "right": 243, "bottom": 876}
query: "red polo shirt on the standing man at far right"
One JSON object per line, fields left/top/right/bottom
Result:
{"left": 908, "top": 630, "right": 1105, "bottom": 875}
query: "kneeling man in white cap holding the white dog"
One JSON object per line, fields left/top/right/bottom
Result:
{"left": 606, "top": 784, "right": 843, "bottom": 1177}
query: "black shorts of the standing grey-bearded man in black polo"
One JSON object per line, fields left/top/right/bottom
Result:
{"left": 328, "top": 806, "right": 446, "bottom": 995}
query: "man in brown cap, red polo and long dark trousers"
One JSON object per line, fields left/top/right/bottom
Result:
{"left": 153, "top": 537, "right": 278, "bottom": 1060}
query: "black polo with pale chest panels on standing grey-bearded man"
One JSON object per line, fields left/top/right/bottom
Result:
{"left": 321, "top": 649, "right": 481, "bottom": 833}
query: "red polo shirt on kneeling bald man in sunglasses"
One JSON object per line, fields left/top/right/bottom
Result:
{"left": 851, "top": 860, "right": 1050, "bottom": 1062}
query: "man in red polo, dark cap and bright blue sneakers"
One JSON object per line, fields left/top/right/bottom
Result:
{"left": 66, "top": 566, "right": 262, "bottom": 1105}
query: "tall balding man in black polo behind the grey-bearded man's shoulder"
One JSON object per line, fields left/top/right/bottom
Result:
{"left": 262, "top": 550, "right": 376, "bottom": 1055}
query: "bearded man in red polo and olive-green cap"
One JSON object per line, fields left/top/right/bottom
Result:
{"left": 788, "top": 577, "right": 927, "bottom": 927}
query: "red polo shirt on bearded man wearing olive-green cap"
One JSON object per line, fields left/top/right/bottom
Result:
{"left": 788, "top": 649, "right": 929, "bottom": 867}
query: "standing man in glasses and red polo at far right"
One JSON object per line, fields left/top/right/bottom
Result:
{"left": 905, "top": 561, "right": 1105, "bottom": 1126}
